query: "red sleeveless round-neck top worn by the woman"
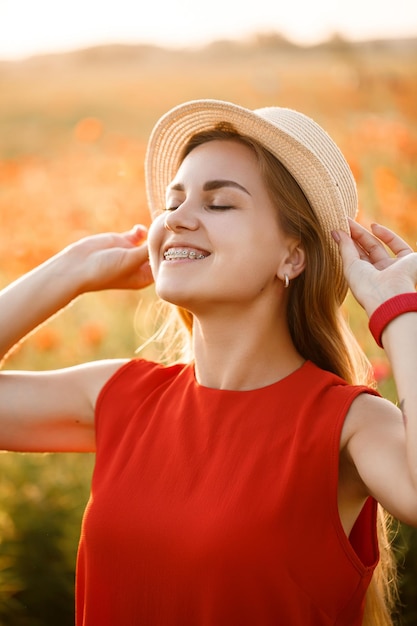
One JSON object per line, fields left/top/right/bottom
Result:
{"left": 77, "top": 360, "right": 378, "bottom": 626}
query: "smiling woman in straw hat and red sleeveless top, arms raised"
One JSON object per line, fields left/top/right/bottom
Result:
{"left": 0, "top": 100, "right": 417, "bottom": 626}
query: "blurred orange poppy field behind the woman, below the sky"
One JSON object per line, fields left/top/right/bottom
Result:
{"left": 0, "top": 35, "right": 417, "bottom": 626}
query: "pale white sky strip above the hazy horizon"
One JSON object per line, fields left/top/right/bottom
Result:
{"left": 0, "top": 0, "right": 417, "bottom": 60}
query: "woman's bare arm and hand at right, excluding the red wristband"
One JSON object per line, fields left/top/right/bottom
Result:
{"left": 339, "top": 223, "right": 417, "bottom": 526}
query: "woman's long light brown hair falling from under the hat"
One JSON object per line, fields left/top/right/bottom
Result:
{"left": 167, "top": 124, "right": 396, "bottom": 626}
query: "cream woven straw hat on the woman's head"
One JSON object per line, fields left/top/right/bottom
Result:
{"left": 145, "top": 100, "right": 358, "bottom": 301}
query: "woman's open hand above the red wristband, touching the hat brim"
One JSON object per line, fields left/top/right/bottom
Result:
{"left": 334, "top": 220, "right": 417, "bottom": 315}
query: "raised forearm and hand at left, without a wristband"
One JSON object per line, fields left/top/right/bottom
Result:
{"left": 0, "top": 226, "right": 153, "bottom": 366}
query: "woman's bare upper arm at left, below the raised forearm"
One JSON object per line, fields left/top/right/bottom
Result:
{"left": 0, "top": 360, "right": 124, "bottom": 452}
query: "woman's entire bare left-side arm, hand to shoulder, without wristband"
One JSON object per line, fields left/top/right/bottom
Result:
{"left": 0, "top": 228, "right": 152, "bottom": 451}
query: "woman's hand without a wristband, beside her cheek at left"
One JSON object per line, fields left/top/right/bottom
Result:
{"left": 65, "top": 225, "right": 153, "bottom": 294}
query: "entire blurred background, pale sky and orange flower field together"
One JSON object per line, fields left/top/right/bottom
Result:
{"left": 0, "top": 0, "right": 417, "bottom": 626}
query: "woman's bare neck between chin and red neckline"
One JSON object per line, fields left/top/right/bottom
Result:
{"left": 193, "top": 304, "right": 304, "bottom": 391}
